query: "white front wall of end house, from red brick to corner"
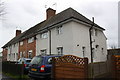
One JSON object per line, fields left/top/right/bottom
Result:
{"left": 36, "top": 23, "right": 73, "bottom": 55}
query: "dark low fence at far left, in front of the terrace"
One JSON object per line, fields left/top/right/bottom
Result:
{"left": 2, "top": 61, "right": 24, "bottom": 77}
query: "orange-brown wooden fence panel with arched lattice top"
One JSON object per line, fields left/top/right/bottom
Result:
{"left": 52, "top": 55, "right": 88, "bottom": 79}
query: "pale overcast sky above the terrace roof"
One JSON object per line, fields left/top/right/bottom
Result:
{"left": 0, "top": 0, "right": 119, "bottom": 52}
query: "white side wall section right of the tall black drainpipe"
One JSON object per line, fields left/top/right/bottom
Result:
{"left": 93, "top": 30, "right": 107, "bottom": 62}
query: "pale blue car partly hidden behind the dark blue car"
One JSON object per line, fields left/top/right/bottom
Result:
{"left": 17, "top": 58, "right": 31, "bottom": 73}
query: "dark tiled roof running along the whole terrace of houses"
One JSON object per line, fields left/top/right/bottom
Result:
{"left": 3, "top": 8, "right": 105, "bottom": 48}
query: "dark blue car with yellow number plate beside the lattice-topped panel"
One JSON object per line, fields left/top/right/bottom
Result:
{"left": 28, "top": 55, "right": 60, "bottom": 78}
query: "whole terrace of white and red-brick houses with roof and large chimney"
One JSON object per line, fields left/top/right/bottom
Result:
{"left": 3, "top": 8, "right": 107, "bottom": 62}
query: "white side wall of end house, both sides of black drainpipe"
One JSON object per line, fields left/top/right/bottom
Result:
{"left": 72, "top": 22, "right": 107, "bottom": 62}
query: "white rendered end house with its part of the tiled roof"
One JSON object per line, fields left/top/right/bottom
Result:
{"left": 36, "top": 8, "right": 107, "bottom": 62}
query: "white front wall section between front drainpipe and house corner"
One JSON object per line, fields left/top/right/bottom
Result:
{"left": 51, "top": 22, "right": 73, "bottom": 54}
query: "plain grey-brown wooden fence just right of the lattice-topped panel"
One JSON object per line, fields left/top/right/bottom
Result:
{"left": 88, "top": 61, "right": 110, "bottom": 78}
